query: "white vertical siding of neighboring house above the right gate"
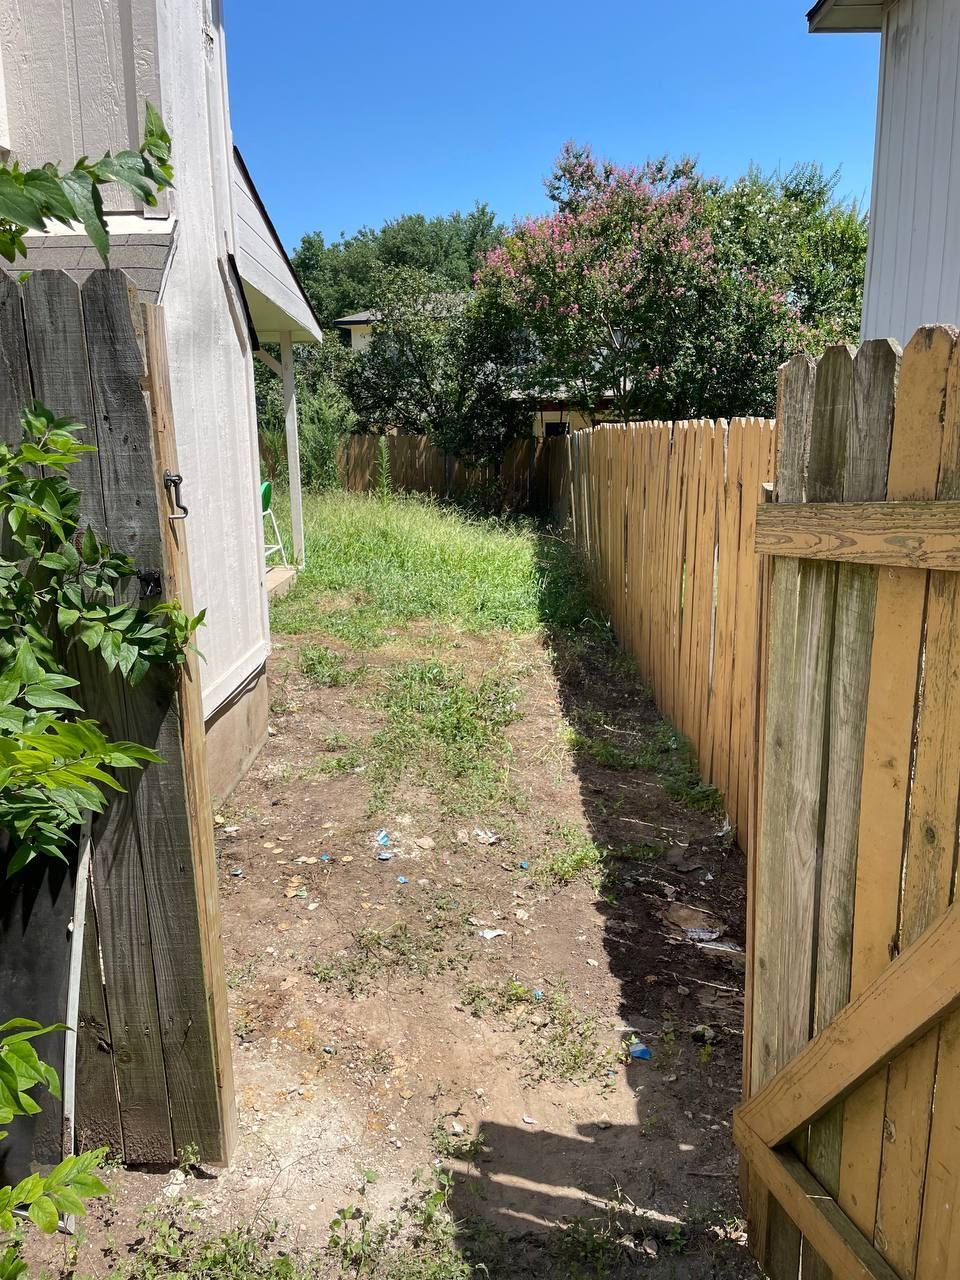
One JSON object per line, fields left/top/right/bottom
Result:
{"left": 863, "top": 0, "right": 960, "bottom": 343}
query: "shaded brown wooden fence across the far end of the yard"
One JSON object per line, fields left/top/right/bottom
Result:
{"left": 340, "top": 434, "right": 543, "bottom": 507}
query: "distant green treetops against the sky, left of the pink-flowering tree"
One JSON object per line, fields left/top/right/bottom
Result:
{"left": 293, "top": 204, "right": 503, "bottom": 325}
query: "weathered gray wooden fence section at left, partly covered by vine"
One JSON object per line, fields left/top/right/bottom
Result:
{"left": 0, "top": 271, "right": 236, "bottom": 1164}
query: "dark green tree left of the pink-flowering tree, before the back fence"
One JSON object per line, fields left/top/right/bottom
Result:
{"left": 343, "top": 268, "right": 530, "bottom": 465}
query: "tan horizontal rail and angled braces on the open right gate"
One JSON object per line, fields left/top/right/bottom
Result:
{"left": 733, "top": 500, "right": 960, "bottom": 1280}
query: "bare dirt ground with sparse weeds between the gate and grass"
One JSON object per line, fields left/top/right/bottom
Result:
{"left": 39, "top": 614, "right": 755, "bottom": 1277}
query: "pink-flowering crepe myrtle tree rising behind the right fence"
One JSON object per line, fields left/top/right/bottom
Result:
{"left": 476, "top": 143, "right": 834, "bottom": 420}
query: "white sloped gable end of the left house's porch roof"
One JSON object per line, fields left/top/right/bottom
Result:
{"left": 233, "top": 147, "right": 323, "bottom": 343}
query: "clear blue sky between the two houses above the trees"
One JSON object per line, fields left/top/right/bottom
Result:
{"left": 225, "top": 0, "right": 879, "bottom": 250}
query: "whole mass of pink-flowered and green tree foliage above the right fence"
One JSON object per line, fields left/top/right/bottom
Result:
{"left": 480, "top": 145, "right": 867, "bottom": 419}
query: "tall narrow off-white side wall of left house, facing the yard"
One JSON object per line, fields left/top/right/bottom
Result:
{"left": 157, "top": 0, "right": 269, "bottom": 716}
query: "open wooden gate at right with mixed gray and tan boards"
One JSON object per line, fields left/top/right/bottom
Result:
{"left": 735, "top": 326, "right": 960, "bottom": 1280}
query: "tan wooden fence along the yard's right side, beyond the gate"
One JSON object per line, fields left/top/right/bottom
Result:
{"left": 541, "top": 419, "right": 774, "bottom": 845}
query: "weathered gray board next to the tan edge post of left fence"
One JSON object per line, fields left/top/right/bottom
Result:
{"left": 83, "top": 271, "right": 219, "bottom": 1160}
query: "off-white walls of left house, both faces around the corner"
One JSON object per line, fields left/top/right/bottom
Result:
{"left": 0, "top": 0, "right": 269, "bottom": 752}
